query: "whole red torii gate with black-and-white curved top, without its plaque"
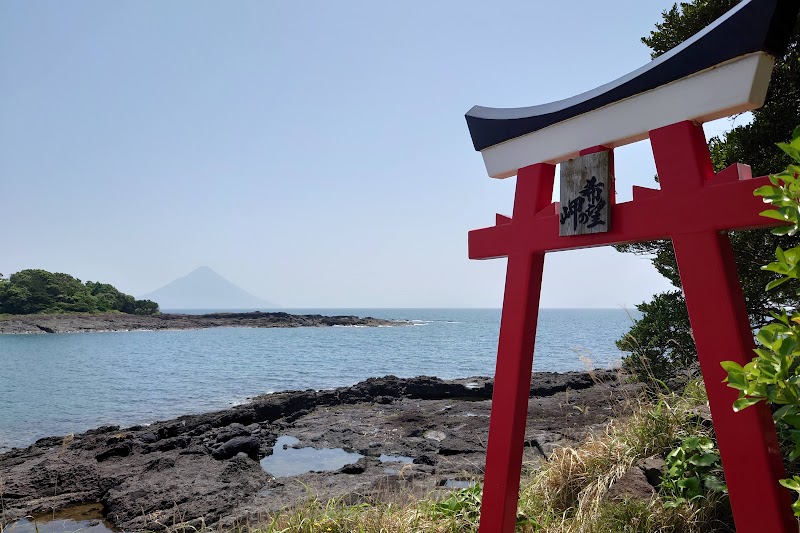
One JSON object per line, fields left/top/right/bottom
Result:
{"left": 467, "top": 0, "right": 800, "bottom": 533}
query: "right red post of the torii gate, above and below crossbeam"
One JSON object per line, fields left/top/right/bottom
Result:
{"left": 650, "top": 122, "right": 797, "bottom": 533}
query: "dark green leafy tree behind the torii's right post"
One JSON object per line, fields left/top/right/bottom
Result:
{"left": 617, "top": 0, "right": 800, "bottom": 378}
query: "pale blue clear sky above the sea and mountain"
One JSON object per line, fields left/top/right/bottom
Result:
{"left": 0, "top": 0, "right": 742, "bottom": 308}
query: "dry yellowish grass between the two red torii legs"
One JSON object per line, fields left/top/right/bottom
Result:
{"left": 518, "top": 383, "right": 729, "bottom": 533}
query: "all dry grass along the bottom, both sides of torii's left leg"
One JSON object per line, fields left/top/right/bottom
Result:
{"left": 155, "top": 376, "right": 732, "bottom": 533}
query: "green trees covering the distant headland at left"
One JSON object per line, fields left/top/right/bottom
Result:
{"left": 0, "top": 269, "right": 158, "bottom": 315}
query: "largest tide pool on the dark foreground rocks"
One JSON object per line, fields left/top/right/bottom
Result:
{"left": 261, "top": 435, "right": 364, "bottom": 477}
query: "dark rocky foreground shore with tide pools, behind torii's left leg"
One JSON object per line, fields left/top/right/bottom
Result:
{"left": 0, "top": 371, "right": 640, "bottom": 531}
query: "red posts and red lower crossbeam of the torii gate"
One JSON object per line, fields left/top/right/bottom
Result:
{"left": 469, "top": 122, "right": 797, "bottom": 533}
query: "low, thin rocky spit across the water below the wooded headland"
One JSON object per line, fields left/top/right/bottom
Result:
{"left": 0, "top": 311, "right": 400, "bottom": 334}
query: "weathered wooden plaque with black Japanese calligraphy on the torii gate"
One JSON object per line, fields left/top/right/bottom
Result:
{"left": 558, "top": 152, "right": 613, "bottom": 236}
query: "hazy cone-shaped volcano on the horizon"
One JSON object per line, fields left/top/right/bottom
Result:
{"left": 142, "top": 267, "right": 279, "bottom": 309}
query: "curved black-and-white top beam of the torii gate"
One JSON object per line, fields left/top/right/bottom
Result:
{"left": 466, "top": 0, "right": 800, "bottom": 178}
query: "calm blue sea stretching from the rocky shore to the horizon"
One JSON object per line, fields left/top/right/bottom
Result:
{"left": 0, "top": 309, "right": 632, "bottom": 451}
